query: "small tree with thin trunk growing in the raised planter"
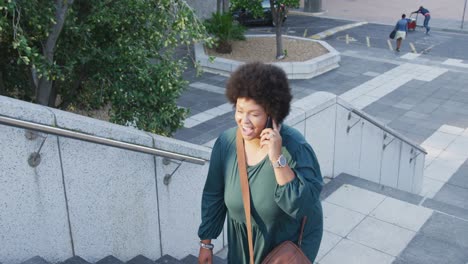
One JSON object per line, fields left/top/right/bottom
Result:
{"left": 230, "top": 0, "right": 299, "bottom": 59}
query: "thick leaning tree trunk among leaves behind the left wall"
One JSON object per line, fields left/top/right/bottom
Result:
{"left": 36, "top": 0, "right": 74, "bottom": 106}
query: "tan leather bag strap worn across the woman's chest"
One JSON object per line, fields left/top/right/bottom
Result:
{"left": 236, "top": 129, "right": 307, "bottom": 264}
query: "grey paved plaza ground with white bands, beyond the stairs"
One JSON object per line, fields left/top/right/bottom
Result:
{"left": 174, "top": 13, "right": 468, "bottom": 264}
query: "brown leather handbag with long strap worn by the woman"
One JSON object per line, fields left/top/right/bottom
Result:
{"left": 236, "top": 129, "right": 312, "bottom": 264}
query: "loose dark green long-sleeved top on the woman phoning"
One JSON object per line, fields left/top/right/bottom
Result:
{"left": 198, "top": 125, "right": 323, "bottom": 264}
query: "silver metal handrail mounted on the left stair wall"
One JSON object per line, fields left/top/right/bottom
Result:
{"left": 0, "top": 115, "right": 206, "bottom": 165}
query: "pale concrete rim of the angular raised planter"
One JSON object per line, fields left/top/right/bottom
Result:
{"left": 195, "top": 34, "right": 341, "bottom": 79}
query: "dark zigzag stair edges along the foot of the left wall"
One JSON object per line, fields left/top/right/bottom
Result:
{"left": 11, "top": 255, "right": 227, "bottom": 264}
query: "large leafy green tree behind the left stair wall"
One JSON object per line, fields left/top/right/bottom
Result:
{"left": 0, "top": 0, "right": 211, "bottom": 135}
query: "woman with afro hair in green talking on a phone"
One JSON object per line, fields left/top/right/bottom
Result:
{"left": 198, "top": 62, "right": 323, "bottom": 264}
